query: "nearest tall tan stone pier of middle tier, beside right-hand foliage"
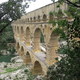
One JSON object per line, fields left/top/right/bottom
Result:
{"left": 47, "top": 36, "right": 59, "bottom": 65}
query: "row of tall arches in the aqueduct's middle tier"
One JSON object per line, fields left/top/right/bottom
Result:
{"left": 15, "top": 27, "right": 59, "bottom": 64}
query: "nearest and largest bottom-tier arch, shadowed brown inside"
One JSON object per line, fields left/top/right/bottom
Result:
{"left": 32, "top": 61, "right": 43, "bottom": 75}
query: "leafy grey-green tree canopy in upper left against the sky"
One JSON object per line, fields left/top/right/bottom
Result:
{"left": 0, "top": 0, "right": 34, "bottom": 33}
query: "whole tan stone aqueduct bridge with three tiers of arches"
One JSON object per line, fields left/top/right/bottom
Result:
{"left": 12, "top": 2, "right": 67, "bottom": 75}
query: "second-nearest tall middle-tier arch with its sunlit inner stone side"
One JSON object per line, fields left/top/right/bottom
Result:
{"left": 33, "top": 28, "right": 42, "bottom": 52}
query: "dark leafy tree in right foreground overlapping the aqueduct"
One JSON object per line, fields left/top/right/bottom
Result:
{"left": 47, "top": 0, "right": 80, "bottom": 80}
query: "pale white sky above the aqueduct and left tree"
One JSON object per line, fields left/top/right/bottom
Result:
{"left": 0, "top": 0, "right": 52, "bottom": 12}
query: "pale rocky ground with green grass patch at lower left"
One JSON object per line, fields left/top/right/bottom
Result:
{"left": 0, "top": 56, "right": 43, "bottom": 80}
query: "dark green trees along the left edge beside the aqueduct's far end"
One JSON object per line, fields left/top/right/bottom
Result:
{"left": 0, "top": 0, "right": 34, "bottom": 51}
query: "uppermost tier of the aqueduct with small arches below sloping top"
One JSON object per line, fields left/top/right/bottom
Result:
{"left": 14, "top": 2, "right": 67, "bottom": 23}
